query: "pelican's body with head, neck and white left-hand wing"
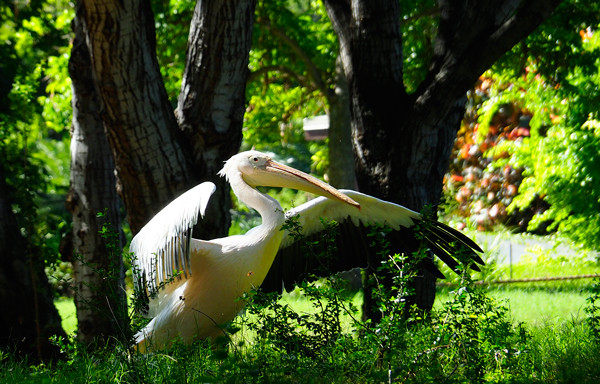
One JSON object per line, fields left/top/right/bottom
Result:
{"left": 130, "top": 151, "right": 358, "bottom": 350}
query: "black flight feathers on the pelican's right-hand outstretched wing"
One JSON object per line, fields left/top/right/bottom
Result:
{"left": 262, "top": 219, "right": 484, "bottom": 291}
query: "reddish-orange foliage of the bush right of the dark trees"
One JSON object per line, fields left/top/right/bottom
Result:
{"left": 444, "top": 77, "right": 546, "bottom": 231}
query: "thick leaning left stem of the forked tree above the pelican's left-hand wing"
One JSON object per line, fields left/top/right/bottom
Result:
{"left": 82, "top": 0, "right": 192, "bottom": 233}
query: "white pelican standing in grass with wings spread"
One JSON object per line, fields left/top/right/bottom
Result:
{"left": 130, "top": 150, "right": 483, "bottom": 351}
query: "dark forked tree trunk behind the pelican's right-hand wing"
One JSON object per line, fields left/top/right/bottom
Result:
{"left": 324, "top": 0, "right": 560, "bottom": 316}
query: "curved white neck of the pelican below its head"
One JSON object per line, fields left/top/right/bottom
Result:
{"left": 229, "top": 173, "right": 285, "bottom": 230}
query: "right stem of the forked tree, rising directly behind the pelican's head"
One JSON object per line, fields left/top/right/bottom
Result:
{"left": 177, "top": 0, "right": 256, "bottom": 238}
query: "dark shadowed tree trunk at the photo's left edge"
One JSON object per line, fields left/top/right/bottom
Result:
{"left": 0, "top": 163, "right": 66, "bottom": 360}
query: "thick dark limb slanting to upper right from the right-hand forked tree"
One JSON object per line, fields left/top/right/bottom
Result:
{"left": 415, "top": 0, "right": 561, "bottom": 123}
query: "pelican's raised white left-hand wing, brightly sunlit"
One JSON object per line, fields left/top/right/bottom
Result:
{"left": 129, "top": 182, "right": 216, "bottom": 312}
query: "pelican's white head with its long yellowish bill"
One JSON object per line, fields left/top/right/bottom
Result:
{"left": 219, "top": 151, "right": 360, "bottom": 209}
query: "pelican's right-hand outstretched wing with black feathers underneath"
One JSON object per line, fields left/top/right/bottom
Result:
{"left": 263, "top": 190, "right": 483, "bottom": 290}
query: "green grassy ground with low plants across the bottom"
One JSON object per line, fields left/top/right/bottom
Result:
{"left": 32, "top": 232, "right": 600, "bottom": 383}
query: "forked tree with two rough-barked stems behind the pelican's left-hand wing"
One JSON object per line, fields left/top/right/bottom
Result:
{"left": 78, "top": 0, "right": 255, "bottom": 234}
